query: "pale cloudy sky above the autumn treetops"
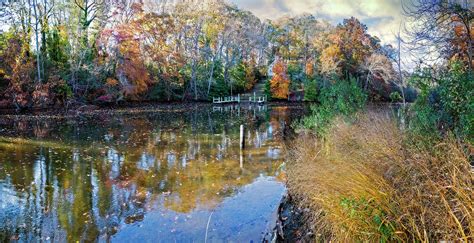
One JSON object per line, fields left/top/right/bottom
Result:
{"left": 231, "top": 0, "right": 402, "bottom": 44}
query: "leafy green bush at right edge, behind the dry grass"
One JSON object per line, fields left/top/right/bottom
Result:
{"left": 409, "top": 62, "right": 474, "bottom": 142}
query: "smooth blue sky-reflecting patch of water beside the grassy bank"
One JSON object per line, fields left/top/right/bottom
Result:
{"left": 112, "top": 177, "right": 285, "bottom": 242}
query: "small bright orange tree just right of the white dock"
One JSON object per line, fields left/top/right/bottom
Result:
{"left": 270, "top": 59, "right": 290, "bottom": 99}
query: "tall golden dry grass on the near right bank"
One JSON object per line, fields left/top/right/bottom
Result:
{"left": 288, "top": 111, "right": 474, "bottom": 242}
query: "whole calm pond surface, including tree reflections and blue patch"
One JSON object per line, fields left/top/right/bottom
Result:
{"left": 0, "top": 105, "right": 302, "bottom": 242}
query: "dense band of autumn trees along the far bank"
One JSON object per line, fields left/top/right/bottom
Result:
{"left": 0, "top": 0, "right": 426, "bottom": 109}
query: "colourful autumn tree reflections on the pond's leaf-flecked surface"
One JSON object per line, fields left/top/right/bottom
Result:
{"left": 0, "top": 104, "right": 304, "bottom": 241}
